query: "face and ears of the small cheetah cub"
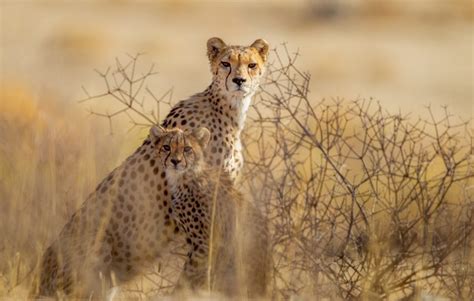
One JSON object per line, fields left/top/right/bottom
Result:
{"left": 150, "top": 126, "right": 211, "bottom": 173}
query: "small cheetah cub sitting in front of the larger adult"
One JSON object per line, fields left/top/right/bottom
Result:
{"left": 152, "top": 127, "right": 269, "bottom": 297}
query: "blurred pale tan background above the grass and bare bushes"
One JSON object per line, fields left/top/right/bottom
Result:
{"left": 1, "top": 0, "right": 474, "bottom": 117}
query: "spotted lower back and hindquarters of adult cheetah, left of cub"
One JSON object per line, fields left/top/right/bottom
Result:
{"left": 31, "top": 134, "right": 182, "bottom": 299}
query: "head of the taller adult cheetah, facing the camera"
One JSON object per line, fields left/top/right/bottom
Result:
{"left": 207, "top": 38, "right": 269, "bottom": 98}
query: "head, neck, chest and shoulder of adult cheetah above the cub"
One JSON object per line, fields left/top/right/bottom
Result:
{"left": 162, "top": 38, "right": 269, "bottom": 180}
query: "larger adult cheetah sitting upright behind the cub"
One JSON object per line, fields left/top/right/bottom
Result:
{"left": 31, "top": 38, "right": 269, "bottom": 298}
